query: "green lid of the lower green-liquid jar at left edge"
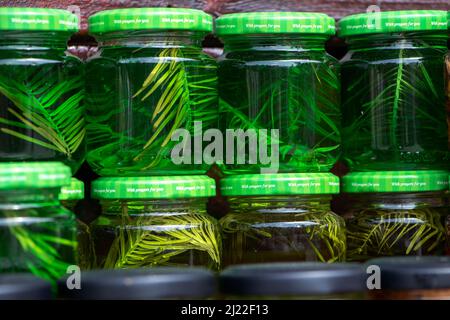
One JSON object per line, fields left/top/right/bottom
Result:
{"left": 0, "top": 162, "right": 72, "bottom": 190}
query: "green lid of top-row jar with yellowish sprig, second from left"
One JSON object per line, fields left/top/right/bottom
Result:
{"left": 89, "top": 8, "right": 213, "bottom": 34}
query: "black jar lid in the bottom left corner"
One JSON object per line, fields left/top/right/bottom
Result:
{"left": 0, "top": 273, "right": 52, "bottom": 300}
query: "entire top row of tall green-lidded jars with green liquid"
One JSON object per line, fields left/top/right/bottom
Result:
{"left": 0, "top": 8, "right": 449, "bottom": 176}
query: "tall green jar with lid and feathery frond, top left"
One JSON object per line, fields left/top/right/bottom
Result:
{"left": 0, "top": 7, "right": 86, "bottom": 173}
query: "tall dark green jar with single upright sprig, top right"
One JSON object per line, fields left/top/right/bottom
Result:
{"left": 339, "top": 11, "right": 449, "bottom": 171}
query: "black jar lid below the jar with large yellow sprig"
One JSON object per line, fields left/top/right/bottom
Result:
{"left": 58, "top": 267, "right": 216, "bottom": 300}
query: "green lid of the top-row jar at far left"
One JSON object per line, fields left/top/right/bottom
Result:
{"left": 0, "top": 7, "right": 78, "bottom": 32}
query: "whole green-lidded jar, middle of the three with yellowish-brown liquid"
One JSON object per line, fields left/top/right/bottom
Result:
{"left": 219, "top": 173, "right": 346, "bottom": 266}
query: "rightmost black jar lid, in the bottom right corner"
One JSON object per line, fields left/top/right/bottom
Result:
{"left": 367, "top": 256, "right": 450, "bottom": 290}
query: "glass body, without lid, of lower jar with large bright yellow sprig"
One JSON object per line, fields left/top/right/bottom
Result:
{"left": 90, "top": 199, "right": 222, "bottom": 269}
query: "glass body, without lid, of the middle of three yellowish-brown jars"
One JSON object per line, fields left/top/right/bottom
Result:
{"left": 220, "top": 196, "right": 346, "bottom": 266}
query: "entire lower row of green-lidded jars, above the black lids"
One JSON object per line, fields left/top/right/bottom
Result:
{"left": 0, "top": 162, "right": 450, "bottom": 280}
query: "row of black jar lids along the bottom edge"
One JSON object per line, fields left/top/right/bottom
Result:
{"left": 0, "top": 257, "right": 450, "bottom": 302}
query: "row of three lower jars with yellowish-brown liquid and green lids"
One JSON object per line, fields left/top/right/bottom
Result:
{"left": 83, "top": 171, "right": 450, "bottom": 269}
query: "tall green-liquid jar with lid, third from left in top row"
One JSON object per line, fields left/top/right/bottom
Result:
{"left": 216, "top": 12, "right": 341, "bottom": 174}
